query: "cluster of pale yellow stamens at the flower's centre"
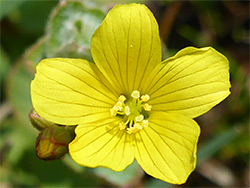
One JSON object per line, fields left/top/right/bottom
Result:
{"left": 110, "top": 90, "right": 152, "bottom": 134}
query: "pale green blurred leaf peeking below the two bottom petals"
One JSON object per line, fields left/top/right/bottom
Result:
{"left": 94, "top": 160, "right": 142, "bottom": 186}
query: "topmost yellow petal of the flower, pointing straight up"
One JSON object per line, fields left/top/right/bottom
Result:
{"left": 91, "top": 4, "right": 161, "bottom": 95}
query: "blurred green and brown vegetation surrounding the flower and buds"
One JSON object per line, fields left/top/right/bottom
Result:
{"left": 0, "top": 0, "right": 250, "bottom": 188}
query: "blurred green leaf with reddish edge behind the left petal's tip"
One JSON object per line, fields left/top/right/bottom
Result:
{"left": 6, "top": 38, "right": 45, "bottom": 127}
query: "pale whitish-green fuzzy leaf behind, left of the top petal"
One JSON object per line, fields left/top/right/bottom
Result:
{"left": 46, "top": 1, "right": 105, "bottom": 61}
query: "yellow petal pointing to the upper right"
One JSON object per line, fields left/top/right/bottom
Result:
{"left": 145, "top": 47, "right": 230, "bottom": 118}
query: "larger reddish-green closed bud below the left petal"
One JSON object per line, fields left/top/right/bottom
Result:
{"left": 36, "top": 125, "right": 75, "bottom": 160}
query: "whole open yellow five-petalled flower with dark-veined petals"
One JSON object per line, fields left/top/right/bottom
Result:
{"left": 31, "top": 4, "right": 230, "bottom": 184}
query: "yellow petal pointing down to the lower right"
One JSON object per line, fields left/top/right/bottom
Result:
{"left": 135, "top": 112, "right": 200, "bottom": 184}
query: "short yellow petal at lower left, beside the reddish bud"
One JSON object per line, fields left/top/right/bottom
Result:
{"left": 69, "top": 117, "right": 134, "bottom": 171}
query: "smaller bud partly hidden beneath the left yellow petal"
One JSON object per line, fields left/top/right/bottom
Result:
{"left": 29, "top": 109, "right": 54, "bottom": 131}
